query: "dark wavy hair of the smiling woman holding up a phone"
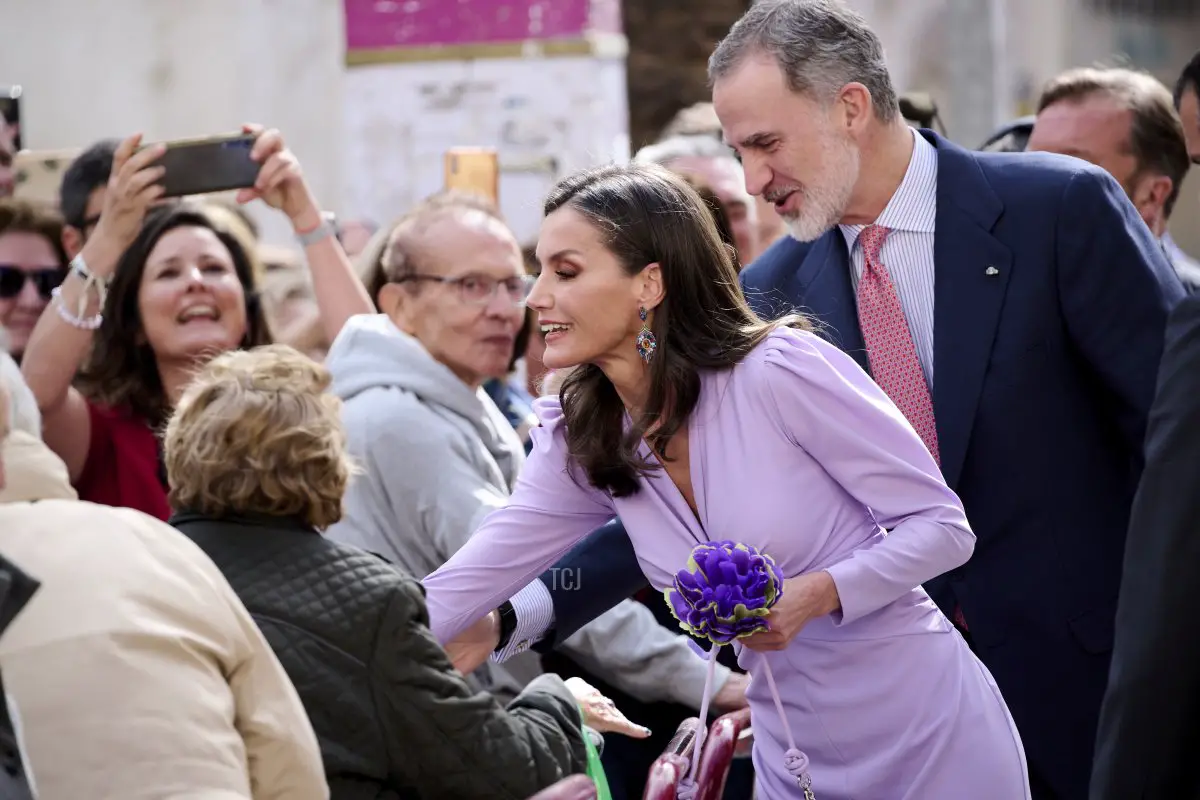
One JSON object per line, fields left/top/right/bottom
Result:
{"left": 77, "top": 200, "right": 271, "bottom": 429}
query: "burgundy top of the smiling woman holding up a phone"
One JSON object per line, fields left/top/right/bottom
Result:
{"left": 76, "top": 401, "right": 170, "bottom": 521}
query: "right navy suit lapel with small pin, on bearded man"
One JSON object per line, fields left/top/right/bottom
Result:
{"left": 929, "top": 134, "right": 1013, "bottom": 488}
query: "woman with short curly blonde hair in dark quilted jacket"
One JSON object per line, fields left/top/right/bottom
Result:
{"left": 164, "top": 345, "right": 619, "bottom": 800}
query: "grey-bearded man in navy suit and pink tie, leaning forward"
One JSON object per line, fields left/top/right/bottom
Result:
{"left": 451, "top": 0, "right": 1183, "bottom": 800}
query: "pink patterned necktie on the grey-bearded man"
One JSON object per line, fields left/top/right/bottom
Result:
{"left": 858, "top": 225, "right": 941, "bottom": 465}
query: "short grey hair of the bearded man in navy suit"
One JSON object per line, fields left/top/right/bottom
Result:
{"left": 708, "top": 0, "right": 900, "bottom": 122}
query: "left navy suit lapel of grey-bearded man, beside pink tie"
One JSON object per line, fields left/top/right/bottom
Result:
{"left": 784, "top": 228, "right": 870, "bottom": 372}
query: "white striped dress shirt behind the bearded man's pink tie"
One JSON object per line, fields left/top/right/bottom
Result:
{"left": 838, "top": 131, "right": 937, "bottom": 389}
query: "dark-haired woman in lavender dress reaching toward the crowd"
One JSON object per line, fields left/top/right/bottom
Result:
{"left": 425, "top": 167, "right": 1028, "bottom": 800}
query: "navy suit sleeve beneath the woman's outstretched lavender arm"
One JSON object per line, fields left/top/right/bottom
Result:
{"left": 534, "top": 519, "right": 648, "bottom": 652}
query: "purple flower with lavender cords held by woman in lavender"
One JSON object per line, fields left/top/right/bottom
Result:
{"left": 662, "top": 541, "right": 815, "bottom": 800}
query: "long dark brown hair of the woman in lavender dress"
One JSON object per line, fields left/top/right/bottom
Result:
{"left": 545, "top": 164, "right": 810, "bottom": 498}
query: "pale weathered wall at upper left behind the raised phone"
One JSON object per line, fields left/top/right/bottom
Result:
{"left": 0, "top": 0, "right": 346, "bottom": 247}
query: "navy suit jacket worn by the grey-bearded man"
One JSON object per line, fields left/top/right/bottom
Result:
{"left": 540, "top": 131, "right": 1183, "bottom": 798}
